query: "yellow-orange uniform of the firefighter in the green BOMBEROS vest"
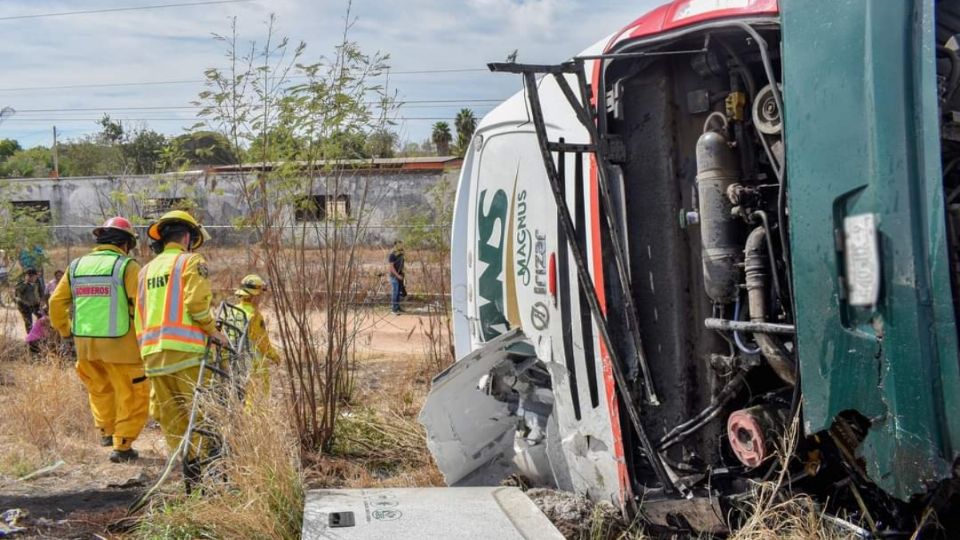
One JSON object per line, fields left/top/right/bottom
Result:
{"left": 50, "top": 244, "right": 150, "bottom": 451}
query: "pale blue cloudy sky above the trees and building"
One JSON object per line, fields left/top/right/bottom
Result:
{"left": 0, "top": 0, "right": 664, "bottom": 147}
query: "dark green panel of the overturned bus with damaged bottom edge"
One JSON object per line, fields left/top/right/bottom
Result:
{"left": 781, "top": 0, "right": 960, "bottom": 499}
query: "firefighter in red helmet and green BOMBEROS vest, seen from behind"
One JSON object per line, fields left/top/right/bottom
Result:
{"left": 50, "top": 217, "right": 150, "bottom": 463}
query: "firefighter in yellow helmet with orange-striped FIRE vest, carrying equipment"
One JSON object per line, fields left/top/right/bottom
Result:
{"left": 135, "top": 210, "right": 228, "bottom": 489}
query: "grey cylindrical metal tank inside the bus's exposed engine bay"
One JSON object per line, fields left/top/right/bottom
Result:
{"left": 697, "top": 131, "right": 743, "bottom": 304}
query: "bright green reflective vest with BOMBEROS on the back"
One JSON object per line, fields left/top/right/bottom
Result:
{"left": 69, "top": 250, "right": 131, "bottom": 338}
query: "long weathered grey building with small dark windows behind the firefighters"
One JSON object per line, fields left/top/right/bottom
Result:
{"left": 5, "top": 157, "right": 462, "bottom": 245}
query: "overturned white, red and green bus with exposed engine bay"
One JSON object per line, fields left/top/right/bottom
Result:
{"left": 421, "top": 0, "right": 960, "bottom": 534}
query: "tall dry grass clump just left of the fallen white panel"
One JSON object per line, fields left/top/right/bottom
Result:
{"left": 136, "top": 394, "right": 304, "bottom": 540}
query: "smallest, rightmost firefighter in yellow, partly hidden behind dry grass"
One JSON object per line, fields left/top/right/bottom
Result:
{"left": 233, "top": 274, "right": 280, "bottom": 410}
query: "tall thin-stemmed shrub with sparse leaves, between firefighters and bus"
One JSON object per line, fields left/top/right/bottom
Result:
{"left": 198, "top": 6, "right": 391, "bottom": 451}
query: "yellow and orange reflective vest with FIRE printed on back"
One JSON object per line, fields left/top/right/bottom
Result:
{"left": 135, "top": 251, "right": 207, "bottom": 357}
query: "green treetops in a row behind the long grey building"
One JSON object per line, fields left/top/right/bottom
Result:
{"left": 0, "top": 106, "right": 477, "bottom": 178}
